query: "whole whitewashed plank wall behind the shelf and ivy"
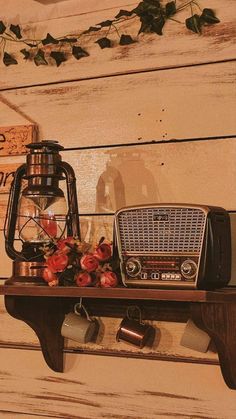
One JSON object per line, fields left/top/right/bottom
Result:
{"left": 0, "top": 0, "right": 236, "bottom": 419}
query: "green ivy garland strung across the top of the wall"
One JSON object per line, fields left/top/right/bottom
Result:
{"left": 0, "top": 0, "right": 220, "bottom": 67}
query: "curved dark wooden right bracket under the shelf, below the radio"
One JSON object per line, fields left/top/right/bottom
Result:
{"left": 191, "top": 302, "right": 236, "bottom": 389}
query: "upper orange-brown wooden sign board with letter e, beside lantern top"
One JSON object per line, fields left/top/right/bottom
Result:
{"left": 0, "top": 125, "right": 37, "bottom": 157}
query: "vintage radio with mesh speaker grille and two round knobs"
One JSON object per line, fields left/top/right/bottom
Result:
{"left": 114, "top": 204, "right": 231, "bottom": 289}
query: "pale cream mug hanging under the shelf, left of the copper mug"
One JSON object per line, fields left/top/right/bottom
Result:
{"left": 61, "top": 303, "right": 98, "bottom": 343}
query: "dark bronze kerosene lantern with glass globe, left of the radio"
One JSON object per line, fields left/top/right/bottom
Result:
{"left": 4, "top": 141, "right": 80, "bottom": 285}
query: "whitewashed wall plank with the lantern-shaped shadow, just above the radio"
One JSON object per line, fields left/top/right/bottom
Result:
{"left": 0, "top": 139, "right": 236, "bottom": 221}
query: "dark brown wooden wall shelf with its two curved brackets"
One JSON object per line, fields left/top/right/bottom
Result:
{"left": 0, "top": 285, "right": 236, "bottom": 389}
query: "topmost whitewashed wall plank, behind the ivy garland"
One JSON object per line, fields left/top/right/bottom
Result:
{"left": 0, "top": 0, "right": 236, "bottom": 89}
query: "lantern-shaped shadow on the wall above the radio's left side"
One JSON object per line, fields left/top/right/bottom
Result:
{"left": 95, "top": 148, "right": 160, "bottom": 213}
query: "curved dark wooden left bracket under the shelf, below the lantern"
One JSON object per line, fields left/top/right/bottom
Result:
{"left": 5, "top": 295, "right": 69, "bottom": 372}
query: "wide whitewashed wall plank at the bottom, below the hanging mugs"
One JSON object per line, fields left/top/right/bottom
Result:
{"left": 0, "top": 349, "right": 236, "bottom": 419}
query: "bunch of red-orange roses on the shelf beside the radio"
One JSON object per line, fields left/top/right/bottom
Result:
{"left": 42, "top": 237, "right": 119, "bottom": 288}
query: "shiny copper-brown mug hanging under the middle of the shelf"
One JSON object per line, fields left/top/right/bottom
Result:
{"left": 116, "top": 306, "right": 155, "bottom": 348}
